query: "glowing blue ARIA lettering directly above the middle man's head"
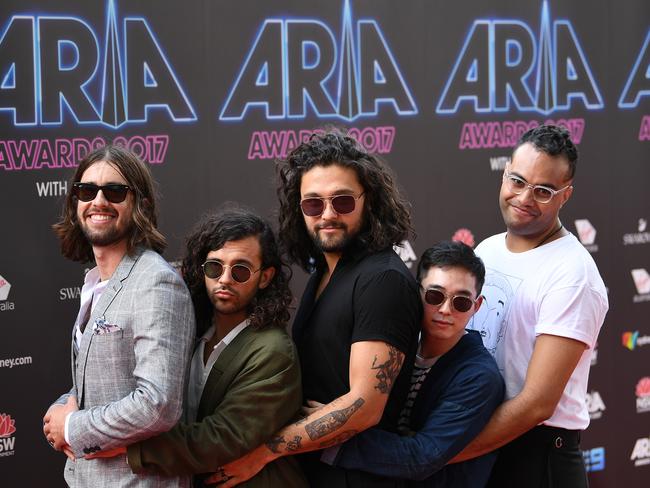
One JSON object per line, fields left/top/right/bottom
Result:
{"left": 219, "top": 0, "right": 418, "bottom": 122}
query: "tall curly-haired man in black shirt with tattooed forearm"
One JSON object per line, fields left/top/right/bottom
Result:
{"left": 213, "top": 131, "right": 422, "bottom": 488}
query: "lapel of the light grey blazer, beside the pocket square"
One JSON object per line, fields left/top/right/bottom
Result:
{"left": 77, "top": 247, "right": 144, "bottom": 408}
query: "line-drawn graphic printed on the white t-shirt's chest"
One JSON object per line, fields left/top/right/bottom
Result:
{"left": 467, "top": 268, "right": 523, "bottom": 359}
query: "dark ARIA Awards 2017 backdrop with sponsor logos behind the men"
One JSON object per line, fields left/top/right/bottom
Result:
{"left": 0, "top": 0, "right": 650, "bottom": 487}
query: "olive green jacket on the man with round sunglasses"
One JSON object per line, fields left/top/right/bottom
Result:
{"left": 128, "top": 326, "right": 307, "bottom": 488}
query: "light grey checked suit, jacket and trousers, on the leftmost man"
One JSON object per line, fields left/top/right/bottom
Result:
{"left": 56, "top": 248, "right": 195, "bottom": 488}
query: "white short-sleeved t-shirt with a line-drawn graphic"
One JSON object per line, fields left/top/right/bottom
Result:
{"left": 467, "top": 233, "right": 609, "bottom": 430}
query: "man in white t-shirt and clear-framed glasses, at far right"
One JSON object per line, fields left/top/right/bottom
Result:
{"left": 453, "top": 125, "right": 608, "bottom": 488}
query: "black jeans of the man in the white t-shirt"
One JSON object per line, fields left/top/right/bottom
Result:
{"left": 487, "top": 425, "right": 589, "bottom": 488}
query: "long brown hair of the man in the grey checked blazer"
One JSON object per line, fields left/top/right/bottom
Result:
{"left": 52, "top": 144, "right": 167, "bottom": 262}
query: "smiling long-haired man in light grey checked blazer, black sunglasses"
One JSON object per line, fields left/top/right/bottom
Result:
{"left": 43, "top": 145, "right": 195, "bottom": 488}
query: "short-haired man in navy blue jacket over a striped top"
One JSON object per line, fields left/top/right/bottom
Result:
{"left": 325, "top": 242, "right": 504, "bottom": 488}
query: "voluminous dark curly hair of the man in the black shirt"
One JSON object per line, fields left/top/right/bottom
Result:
{"left": 276, "top": 129, "right": 414, "bottom": 270}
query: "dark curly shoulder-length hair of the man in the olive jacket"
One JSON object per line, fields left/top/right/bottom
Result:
{"left": 182, "top": 206, "right": 292, "bottom": 335}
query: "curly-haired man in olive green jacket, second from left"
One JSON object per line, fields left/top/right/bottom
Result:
{"left": 90, "top": 209, "right": 307, "bottom": 487}
